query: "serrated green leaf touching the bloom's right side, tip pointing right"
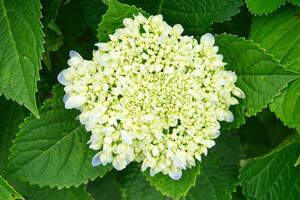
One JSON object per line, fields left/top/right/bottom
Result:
{"left": 216, "top": 34, "right": 300, "bottom": 127}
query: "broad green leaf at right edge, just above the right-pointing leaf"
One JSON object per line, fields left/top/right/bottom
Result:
{"left": 250, "top": 7, "right": 300, "bottom": 72}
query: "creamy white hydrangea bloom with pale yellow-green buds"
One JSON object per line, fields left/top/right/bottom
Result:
{"left": 58, "top": 14, "right": 245, "bottom": 180}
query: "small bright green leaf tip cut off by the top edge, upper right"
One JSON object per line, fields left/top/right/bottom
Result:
{"left": 246, "top": 0, "right": 286, "bottom": 15}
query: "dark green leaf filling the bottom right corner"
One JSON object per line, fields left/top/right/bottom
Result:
{"left": 240, "top": 137, "right": 300, "bottom": 200}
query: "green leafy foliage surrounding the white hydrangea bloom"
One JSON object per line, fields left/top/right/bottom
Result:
{"left": 0, "top": 0, "right": 300, "bottom": 200}
